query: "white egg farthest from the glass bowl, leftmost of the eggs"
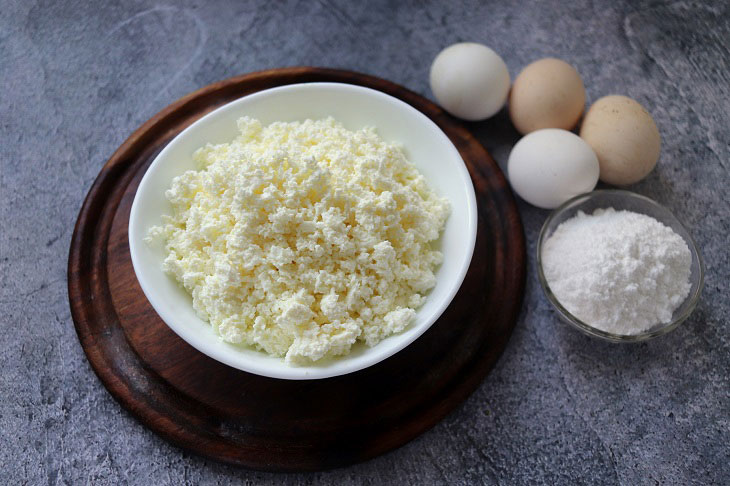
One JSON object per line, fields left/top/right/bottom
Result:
{"left": 430, "top": 42, "right": 510, "bottom": 121}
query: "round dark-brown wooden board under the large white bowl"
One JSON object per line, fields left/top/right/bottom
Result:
{"left": 68, "top": 67, "right": 525, "bottom": 471}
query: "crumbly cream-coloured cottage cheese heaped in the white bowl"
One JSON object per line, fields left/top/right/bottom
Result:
{"left": 148, "top": 117, "right": 449, "bottom": 364}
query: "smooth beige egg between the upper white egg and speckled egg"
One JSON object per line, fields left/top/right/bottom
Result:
{"left": 509, "top": 58, "right": 586, "bottom": 134}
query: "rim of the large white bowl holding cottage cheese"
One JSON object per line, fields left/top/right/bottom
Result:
{"left": 128, "top": 82, "right": 478, "bottom": 380}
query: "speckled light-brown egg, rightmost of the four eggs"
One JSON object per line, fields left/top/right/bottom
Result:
{"left": 580, "top": 95, "right": 661, "bottom": 185}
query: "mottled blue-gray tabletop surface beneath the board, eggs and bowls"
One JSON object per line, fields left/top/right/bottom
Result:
{"left": 0, "top": 0, "right": 730, "bottom": 485}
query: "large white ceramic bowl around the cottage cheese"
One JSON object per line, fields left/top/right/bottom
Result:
{"left": 129, "top": 83, "right": 477, "bottom": 380}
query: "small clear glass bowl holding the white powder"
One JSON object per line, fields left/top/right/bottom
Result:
{"left": 537, "top": 189, "right": 705, "bottom": 342}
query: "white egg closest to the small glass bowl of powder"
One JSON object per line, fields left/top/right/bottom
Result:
{"left": 507, "top": 128, "right": 599, "bottom": 209}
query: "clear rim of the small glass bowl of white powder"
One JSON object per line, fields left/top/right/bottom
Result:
{"left": 536, "top": 189, "right": 705, "bottom": 343}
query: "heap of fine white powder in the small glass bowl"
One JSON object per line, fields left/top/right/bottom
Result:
{"left": 542, "top": 208, "right": 692, "bottom": 335}
